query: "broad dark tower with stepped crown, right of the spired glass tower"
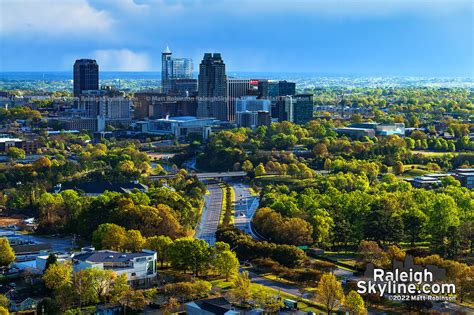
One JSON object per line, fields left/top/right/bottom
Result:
{"left": 197, "top": 53, "right": 228, "bottom": 121}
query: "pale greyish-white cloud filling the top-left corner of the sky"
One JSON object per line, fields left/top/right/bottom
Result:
{"left": 0, "top": 0, "right": 114, "bottom": 35}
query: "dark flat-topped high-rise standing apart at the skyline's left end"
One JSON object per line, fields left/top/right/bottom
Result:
{"left": 74, "top": 59, "right": 99, "bottom": 97}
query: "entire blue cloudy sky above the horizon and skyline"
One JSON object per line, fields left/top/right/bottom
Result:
{"left": 0, "top": 0, "right": 474, "bottom": 78}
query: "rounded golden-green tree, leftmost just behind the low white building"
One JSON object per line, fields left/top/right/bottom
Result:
{"left": 92, "top": 223, "right": 126, "bottom": 251}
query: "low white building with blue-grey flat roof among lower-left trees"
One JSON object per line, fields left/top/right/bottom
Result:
{"left": 72, "top": 248, "right": 157, "bottom": 287}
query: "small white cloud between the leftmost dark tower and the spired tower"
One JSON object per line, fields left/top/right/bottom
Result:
{"left": 93, "top": 49, "right": 150, "bottom": 71}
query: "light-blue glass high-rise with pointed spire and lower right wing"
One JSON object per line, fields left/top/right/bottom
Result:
{"left": 161, "top": 46, "right": 193, "bottom": 93}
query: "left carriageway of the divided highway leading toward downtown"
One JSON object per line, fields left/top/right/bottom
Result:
{"left": 195, "top": 183, "right": 223, "bottom": 245}
